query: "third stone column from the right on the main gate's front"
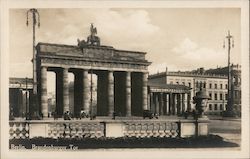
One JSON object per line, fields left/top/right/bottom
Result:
{"left": 108, "top": 71, "right": 114, "bottom": 116}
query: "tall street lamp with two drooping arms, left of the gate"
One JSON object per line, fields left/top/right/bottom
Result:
{"left": 26, "top": 8, "right": 40, "bottom": 116}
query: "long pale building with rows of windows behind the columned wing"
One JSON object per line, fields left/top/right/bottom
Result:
{"left": 149, "top": 65, "right": 241, "bottom": 114}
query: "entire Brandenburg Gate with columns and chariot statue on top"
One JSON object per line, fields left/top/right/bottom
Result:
{"left": 36, "top": 25, "right": 151, "bottom": 118}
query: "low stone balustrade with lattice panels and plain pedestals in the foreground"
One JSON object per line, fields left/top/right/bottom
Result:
{"left": 9, "top": 120, "right": 208, "bottom": 139}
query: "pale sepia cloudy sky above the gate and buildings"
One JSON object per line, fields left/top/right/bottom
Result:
{"left": 9, "top": 8, "right": 241, "bottom": 78}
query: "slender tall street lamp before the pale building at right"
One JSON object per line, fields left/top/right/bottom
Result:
{"left": 223, "top": 31, "right": 234, "bottom": 115}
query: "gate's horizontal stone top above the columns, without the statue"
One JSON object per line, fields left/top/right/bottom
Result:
{"left": 37, "top": 43, "right": 151, "bottom": 72}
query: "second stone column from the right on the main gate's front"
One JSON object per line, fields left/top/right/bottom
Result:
{"left": 126, "top": 72, "right": 131, "bottom": 116}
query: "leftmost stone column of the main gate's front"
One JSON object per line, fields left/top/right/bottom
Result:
{"left": 41, "top": 66, "right": 48, "bottom": 118}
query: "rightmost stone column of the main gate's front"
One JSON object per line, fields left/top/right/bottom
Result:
{"left": 142, "top": 73, "right": 148, "bottom": 110}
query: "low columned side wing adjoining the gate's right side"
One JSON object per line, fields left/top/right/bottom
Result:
{"left": 148, "top": 82, "right": 191, "bottom": 116}
